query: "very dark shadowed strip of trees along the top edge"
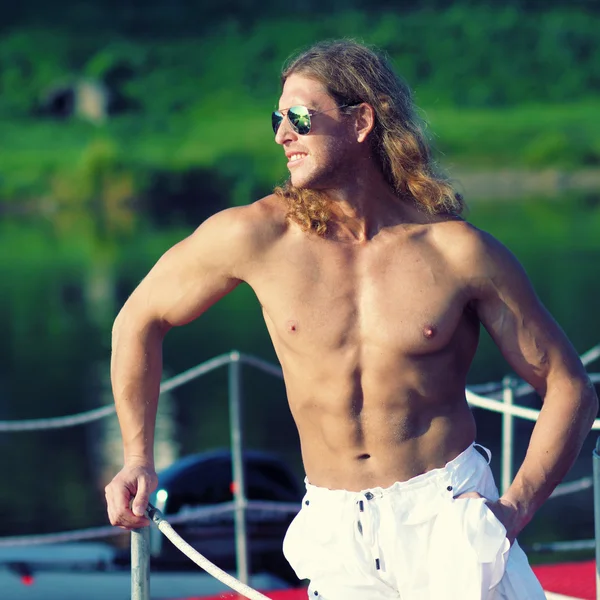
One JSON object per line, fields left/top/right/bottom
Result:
{"left": 0, "top": 0, "right": 600, "bottom": 36}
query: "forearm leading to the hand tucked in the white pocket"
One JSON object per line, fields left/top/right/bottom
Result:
{"left": 502, "top": 377, "right": 598, "bottom": 531}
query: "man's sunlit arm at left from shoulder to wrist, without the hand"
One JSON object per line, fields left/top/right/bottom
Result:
{"left": 111, "top": 213, "right": 244, "bottom": 465}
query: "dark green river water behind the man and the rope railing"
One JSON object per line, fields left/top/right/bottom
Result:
{"left": 0, "top": 197, "right": 600, "bottom": 552}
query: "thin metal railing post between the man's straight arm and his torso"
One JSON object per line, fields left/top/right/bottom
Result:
{"left": 228, "top": 350, "right": 250, "bottom": 584}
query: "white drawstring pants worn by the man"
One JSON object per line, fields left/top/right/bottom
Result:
{"left": 283, "top": 445, "right": 546, "bottom": 600}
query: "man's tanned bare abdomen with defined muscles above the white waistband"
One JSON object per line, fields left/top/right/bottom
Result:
{"left": 287, "top": 364, "right": 475, "bottom": 491}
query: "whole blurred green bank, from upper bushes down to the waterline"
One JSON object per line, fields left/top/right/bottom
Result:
{"left": 0, "top": 5, "right": 600, "bottom": 209}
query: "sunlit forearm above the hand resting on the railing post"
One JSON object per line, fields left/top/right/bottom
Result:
{"left": 111, "top": 312, "right": 165, "bottom": 466}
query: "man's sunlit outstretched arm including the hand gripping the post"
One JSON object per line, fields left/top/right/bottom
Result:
{"left": 106, "top": 206, "right": 278, "bottom": 527}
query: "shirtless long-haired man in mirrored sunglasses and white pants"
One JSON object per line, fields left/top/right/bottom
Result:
{"left": 106, "top": 41, "right": 598, "bottom": 600}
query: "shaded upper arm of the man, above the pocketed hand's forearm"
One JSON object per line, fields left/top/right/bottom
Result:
{"left": 474, "top": 237, "right": 582, "bottom": 394}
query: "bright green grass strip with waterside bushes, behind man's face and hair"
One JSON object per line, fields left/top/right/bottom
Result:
{"left": 0, "top": 102, "right": 600, "bottom": 232}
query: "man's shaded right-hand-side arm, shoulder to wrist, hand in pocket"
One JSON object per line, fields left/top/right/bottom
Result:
{"left": 464, "top": 227, "right": 598, "bottom": 537}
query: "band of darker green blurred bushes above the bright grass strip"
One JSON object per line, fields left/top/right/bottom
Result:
{"left": 0, "top": 4, "right": 600, "bottom": 119}
